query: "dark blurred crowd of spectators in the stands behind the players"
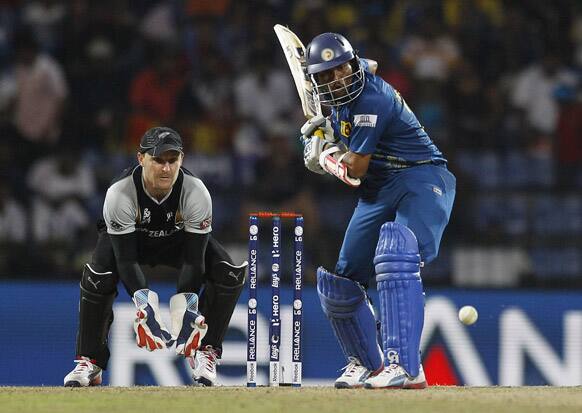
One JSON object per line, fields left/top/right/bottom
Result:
{"left": 0, "top": 0, "right": 582, "bottom": 287}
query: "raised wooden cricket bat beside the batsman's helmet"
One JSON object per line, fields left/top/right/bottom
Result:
{"left": 273, "top": 24, "right": 321, "bottom": 119}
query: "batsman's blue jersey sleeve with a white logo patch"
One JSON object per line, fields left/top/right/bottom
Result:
{"left": 349, "top": 84, "right": 394, "bottom": 155}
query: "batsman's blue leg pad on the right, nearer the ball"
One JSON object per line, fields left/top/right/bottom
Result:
{"left": 374, "top": 222, "right": 424, "bottom": 376}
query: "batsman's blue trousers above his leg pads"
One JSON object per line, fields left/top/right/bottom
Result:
{"left": 335, "top": 164, "right": 456, "bottom": 286}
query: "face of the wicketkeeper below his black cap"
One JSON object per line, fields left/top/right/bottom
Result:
{"left": 137, "top": 151, "right": 184, "bottom": 197}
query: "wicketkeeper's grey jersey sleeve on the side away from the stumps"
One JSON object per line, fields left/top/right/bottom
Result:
{"left": 103, "top": 179, "right": 138, "bottom": 235}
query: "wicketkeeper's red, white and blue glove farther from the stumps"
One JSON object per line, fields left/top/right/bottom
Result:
{"left": 133, "top": 288, "right": 174, "bottom": 351}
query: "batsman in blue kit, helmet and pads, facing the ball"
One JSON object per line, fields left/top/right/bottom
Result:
{"left": 294, "top": 33, "right": 456, "bottom": 389}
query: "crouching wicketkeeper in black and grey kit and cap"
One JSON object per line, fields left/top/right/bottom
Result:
{"left": 64, "top": 127, "right": 247, "bottom": 387}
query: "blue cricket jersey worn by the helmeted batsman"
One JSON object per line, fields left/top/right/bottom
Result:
{"left": 331, "top": 59, "right": 446, "bottom": 188}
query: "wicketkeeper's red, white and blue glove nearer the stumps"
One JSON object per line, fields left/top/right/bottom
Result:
{"left": 170, "top": 293, "right": 208, "bottom": 357}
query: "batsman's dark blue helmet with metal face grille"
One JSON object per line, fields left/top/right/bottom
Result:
{"left": 305, "top": 33, "right": 365, "bottom": 106}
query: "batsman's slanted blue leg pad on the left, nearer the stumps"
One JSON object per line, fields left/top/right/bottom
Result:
{"left": 317, "top": 267, "right": 383, "bottom": 371}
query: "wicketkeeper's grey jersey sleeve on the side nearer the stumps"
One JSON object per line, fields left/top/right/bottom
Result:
{"left": 180, "top": 175, "right": 212, "bottom": 234}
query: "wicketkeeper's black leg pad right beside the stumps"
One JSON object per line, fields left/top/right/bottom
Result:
{"left": 200, "top": 261, "right": 248, "bottom": 352}
